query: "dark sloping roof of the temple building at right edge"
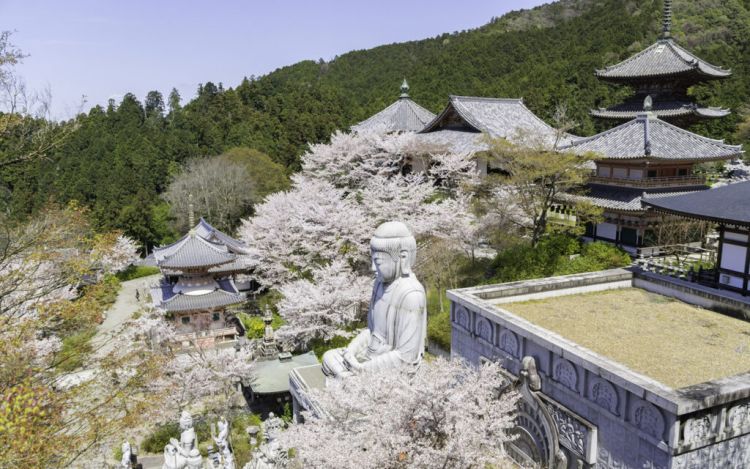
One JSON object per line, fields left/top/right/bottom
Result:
{"left": 643, "top": 182, "right": 750, "bottom": 226}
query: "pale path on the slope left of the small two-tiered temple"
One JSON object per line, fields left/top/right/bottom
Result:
{"left": 91, "top": 274, "right": 160, "bottom": 356}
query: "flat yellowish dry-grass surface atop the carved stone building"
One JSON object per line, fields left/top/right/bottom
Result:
{"left": 500, "top": 288, "right": 750, "bottom": 389}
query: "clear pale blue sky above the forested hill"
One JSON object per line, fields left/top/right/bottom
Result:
{"left": 0, "top": 0, "right": 549, "bottom": 118}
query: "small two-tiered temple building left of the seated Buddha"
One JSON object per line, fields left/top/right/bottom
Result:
{"left": 151, "top": 218, "right": 253, "bottom": 347}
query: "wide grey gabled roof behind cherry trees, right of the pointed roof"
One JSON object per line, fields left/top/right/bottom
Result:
{"left": 420, "top": 96, "right": 570, "bottom": 151}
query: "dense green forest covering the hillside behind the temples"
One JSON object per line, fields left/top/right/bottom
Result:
{"left": 0, "top": 0, "right": 750, "bottom": 248}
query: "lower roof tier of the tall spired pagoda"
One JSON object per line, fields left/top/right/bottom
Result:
{"left": 591, "top": 98, "right": 730, "bottom": 120}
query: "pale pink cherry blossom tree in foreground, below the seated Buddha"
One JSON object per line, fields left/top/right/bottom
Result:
{"left": 279, "top": 358, "right": 517, "bottom": 468}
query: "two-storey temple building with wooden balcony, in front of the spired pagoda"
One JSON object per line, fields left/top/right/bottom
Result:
{"left": 561, "top": 112, "right": 743, "bottom": 253}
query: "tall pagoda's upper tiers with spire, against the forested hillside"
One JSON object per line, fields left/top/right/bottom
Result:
{"left": 591, "top": 0, "right": 732, "bottom": 126}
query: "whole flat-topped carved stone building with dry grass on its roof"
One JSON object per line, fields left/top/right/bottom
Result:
{"left": 448, "top": 266, "right": 750, "bottom": 469}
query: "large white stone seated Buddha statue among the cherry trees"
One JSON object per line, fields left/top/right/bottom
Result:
{"left": 323, "top": 222, "right": 427, "bottom": 377}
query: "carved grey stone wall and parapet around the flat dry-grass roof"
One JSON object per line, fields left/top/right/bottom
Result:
{"left": 449, "top": 270, "right": 750, "bottom": 469}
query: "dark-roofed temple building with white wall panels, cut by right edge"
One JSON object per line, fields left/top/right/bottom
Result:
{"left": 643, "top": 182, "right": 750, "bottom": 296}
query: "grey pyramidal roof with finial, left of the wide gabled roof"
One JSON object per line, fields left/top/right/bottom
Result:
{"left": 352, "top": 80, "right": 435, "bottom": 132}
